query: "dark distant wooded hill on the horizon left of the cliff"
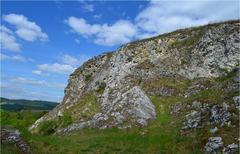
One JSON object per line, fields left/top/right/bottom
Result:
{"left": 0, "top": 97, "right": 58, "bottom": 111}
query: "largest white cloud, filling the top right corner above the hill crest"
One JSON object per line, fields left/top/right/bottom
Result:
{"left": 135, "top": 0, "right": 239, "bottom": 34}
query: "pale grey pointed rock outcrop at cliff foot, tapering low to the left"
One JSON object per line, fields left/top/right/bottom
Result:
{"left": 63, "top": 87, "right": 156, "bottom": 133}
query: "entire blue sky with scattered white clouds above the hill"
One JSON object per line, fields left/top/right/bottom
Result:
{"left": 0, "top": 0, "right": 239, "bottom": 102}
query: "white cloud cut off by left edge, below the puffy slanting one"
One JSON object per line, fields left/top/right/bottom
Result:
{"left": 0, "top": 25, "right": 20, "bottom": 52}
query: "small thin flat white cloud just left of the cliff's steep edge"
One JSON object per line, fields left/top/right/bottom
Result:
{"left": 37, "top": 63, "right": 75, "bottom": 73}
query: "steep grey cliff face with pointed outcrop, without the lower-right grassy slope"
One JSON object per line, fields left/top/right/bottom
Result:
{"left": 30, "top": 21, "right": 240, "bottom": 140}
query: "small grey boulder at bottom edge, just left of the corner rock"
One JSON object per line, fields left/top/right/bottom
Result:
{"left": 204, "top": 137, "right": 223, "bottom": 154}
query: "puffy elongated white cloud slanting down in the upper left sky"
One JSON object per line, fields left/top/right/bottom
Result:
{"left": 3, "top": 14, "right": 48, "bottom": 42}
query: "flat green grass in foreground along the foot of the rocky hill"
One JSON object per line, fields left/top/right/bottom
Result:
{"left": 1, "top": 97, "right": 197, "bottom": 154}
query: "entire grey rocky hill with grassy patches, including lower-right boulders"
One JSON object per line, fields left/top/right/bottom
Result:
{"left": 30, "top": 20, "right": 240, "bottom": 153}
